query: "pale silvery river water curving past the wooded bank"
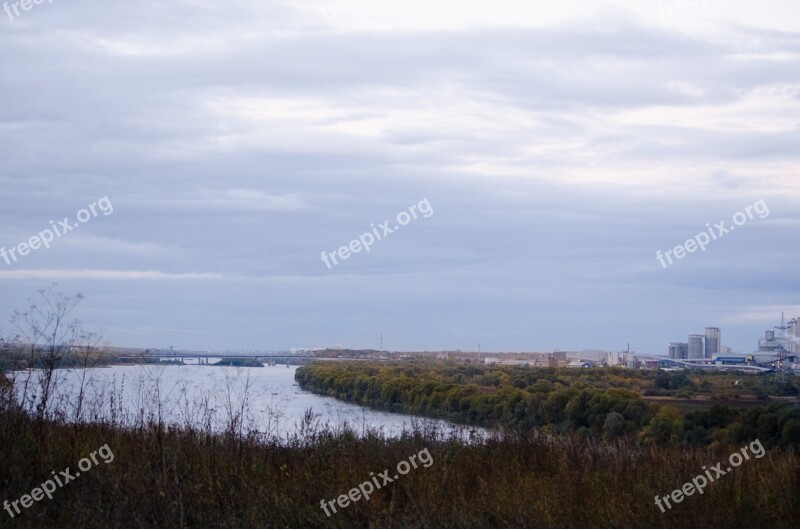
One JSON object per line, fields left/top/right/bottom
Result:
{"left": 13, "top": 360, "right": 485, "bottom": 440}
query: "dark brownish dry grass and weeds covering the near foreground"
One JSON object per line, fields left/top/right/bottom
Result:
{"left": 0, "top": 370, "right": 800, "bottom": 529}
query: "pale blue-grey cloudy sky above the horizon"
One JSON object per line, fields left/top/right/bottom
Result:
{"left": 0, "top": 0, "right": 800, "bottom": 354}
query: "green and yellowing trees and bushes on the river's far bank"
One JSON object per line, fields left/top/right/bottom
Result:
{"left": 295, "top": 361, "right": 800, "bottom": 449}
